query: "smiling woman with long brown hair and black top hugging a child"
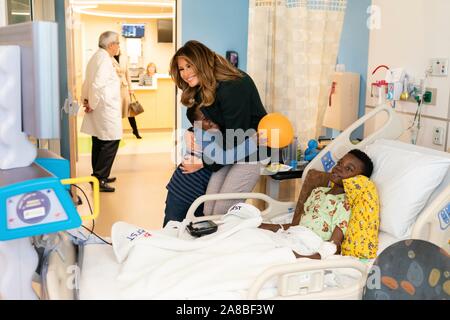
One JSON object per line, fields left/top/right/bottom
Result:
{"left": 170, "top": 41, "right": 267, "bottom": 215}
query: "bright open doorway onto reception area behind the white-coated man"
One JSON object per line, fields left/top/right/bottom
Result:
{"left": 65, "top": 0, "right": 177, "bottom": 235}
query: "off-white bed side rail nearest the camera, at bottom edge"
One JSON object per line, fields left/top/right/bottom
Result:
{"left": 247, "top": 257, "right": 368, "bottom": 300}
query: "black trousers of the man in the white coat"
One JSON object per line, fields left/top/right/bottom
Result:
{"left": 91, "top": 137, "right": 120, "bottom": 181}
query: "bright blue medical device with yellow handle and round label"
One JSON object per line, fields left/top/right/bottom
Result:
{"left": 0, "top": 150, "right": 99, "bottom": 241}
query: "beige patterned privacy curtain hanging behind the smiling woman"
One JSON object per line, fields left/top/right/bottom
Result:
{"left": 248, "top": 0, "right": 347, "bottom": 150}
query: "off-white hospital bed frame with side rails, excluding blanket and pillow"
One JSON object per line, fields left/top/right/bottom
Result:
{"left": 41, "top": 105, "right": 450, "bottom": 299}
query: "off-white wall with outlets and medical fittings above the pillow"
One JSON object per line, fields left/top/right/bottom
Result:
{"left": 366, "top": 0, "right": 450, "bottom": 150}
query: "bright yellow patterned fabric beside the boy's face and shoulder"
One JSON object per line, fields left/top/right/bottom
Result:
{"left": 341, "top": 176, "right": 380, "bottom": 259}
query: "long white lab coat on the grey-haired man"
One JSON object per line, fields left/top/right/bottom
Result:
{"left": 81, "top": 49, "right": 123, "bottom": 141}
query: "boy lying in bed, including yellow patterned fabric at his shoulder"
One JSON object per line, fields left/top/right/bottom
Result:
{"left": 260, "top": 149, "right": 379, "bottom": 259}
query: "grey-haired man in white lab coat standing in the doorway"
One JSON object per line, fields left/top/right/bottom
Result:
{"left": 81, "top": 31, "right": 122, "bottom": 192}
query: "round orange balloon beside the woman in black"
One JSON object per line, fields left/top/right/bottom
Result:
{"left": 258, "top": 112, "right": 294, "bottom": 148}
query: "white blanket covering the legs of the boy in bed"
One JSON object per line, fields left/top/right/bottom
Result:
{"left": 112, "top": 202, "right": 348, "bottom": 299}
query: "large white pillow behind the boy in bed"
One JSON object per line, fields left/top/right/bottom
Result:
{"left": 365, "top": 139, "right": 450, "bottom": 238}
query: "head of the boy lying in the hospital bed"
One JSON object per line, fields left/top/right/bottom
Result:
{"left": 331, "top": 149, "right": 373, "bottom": 185}
